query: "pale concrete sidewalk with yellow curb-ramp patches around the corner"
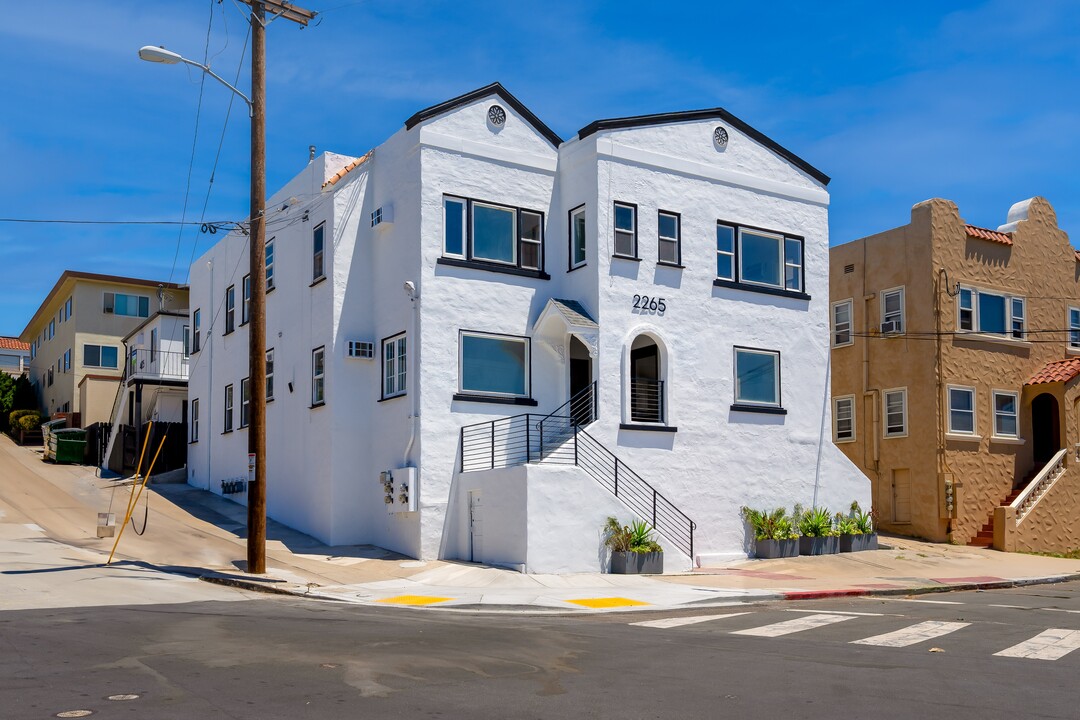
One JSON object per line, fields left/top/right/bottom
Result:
{"left": 0, "top": 437, "right": 1080, "bottom": 612}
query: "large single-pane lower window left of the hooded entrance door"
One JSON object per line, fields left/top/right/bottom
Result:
{"left": 458, "top": 330, "right": 531, "bottom": 397}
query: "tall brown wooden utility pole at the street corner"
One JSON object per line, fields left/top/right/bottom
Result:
{"left": 241, "top": 0, "right": 315, "bottom": 573}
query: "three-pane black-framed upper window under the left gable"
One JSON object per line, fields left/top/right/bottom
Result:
{"left": 443, "top": 195, "right": 543, "bottom": 274}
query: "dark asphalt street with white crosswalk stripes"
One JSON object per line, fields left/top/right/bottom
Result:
{"left": 0, "top": 583, "right": 1080, "bottom": 720}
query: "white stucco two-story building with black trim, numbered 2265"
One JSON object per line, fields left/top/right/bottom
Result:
{"left": 188, "top": 83, "right": 869, "bottom": 572}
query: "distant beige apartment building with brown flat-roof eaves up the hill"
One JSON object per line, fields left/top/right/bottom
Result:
{"left": 19, "top": 270, "right": 188, "bottom": 427}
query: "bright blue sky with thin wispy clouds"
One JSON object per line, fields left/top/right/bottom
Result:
{"left": 0, "top": 0, "right": 1080, "bottom": 335}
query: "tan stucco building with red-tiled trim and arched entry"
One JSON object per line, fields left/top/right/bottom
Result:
{"left": 829, "top": 198, "right": 1080, "bottom": 551}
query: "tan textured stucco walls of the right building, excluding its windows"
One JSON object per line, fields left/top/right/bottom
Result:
{"left": 831, "top": 198, "right": 1080, "bottom": 549}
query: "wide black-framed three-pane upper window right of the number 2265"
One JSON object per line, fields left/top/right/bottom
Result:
{"left": 715, "top": 220, "right": 806, "bottom": 297}
